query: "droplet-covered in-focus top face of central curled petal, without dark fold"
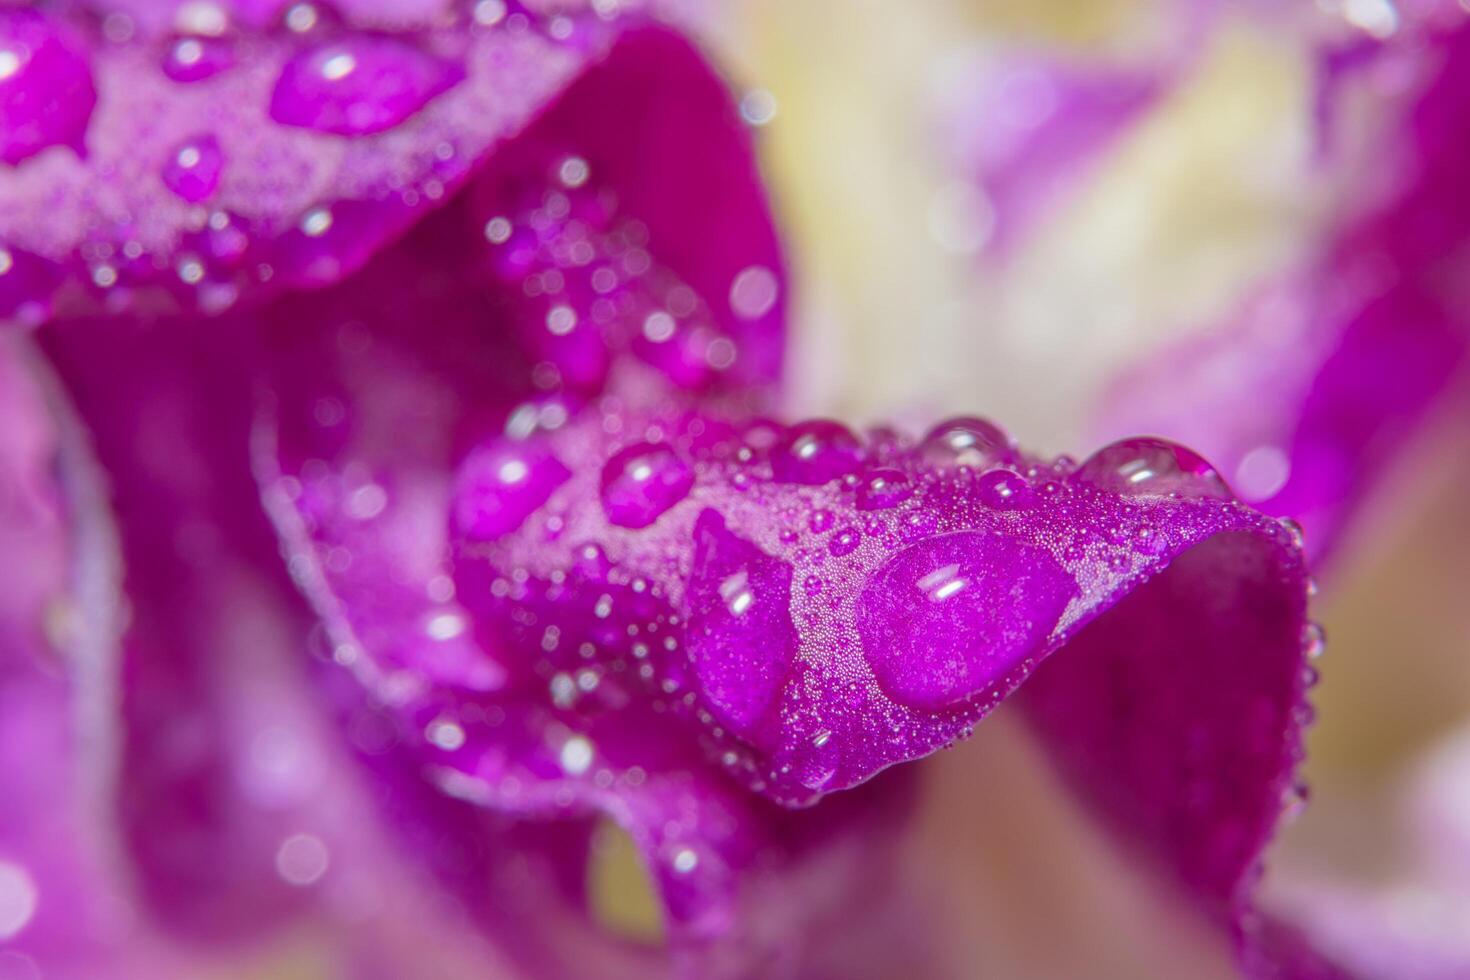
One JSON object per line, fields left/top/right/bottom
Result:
{"left": 438, "top": 399, "right": 1311, "bottom": 802}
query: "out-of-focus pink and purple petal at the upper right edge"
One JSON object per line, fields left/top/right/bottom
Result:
{"left": 1103, "top": 18, "right": 1470, "bottom": 564}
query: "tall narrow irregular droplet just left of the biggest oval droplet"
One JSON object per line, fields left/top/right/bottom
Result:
{"left": 688, "top": 510, "right": 797, "bottom": 735}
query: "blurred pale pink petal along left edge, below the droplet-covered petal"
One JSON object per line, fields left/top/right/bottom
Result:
{"left": 0, "top": 338, "right": 135, "bottom": 977}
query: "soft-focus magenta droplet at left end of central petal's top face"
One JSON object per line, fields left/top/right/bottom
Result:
{"left": 454, "top": 439, "right": 572, "bottom": 541}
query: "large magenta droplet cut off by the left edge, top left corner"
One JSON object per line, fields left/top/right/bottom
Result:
{"left": 0, "top": 9, "right": 97, "bottom": 166}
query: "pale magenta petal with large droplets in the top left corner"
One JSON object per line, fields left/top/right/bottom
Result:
{"left": 0, "top": 4, "right": 617, "bottom": 320}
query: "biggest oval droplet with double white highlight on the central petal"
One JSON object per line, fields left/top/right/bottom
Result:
{"left": 857, "top": 530, "right": 1078, "bottom": 710}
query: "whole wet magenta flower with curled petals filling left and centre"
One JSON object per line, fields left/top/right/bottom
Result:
{"left": 0, "top": 0, "right": 1458, "bottom": 977}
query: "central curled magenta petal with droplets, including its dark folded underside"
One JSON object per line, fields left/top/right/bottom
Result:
{"left": 257, "top": 252, "right": 1311, "bottom": 975}
